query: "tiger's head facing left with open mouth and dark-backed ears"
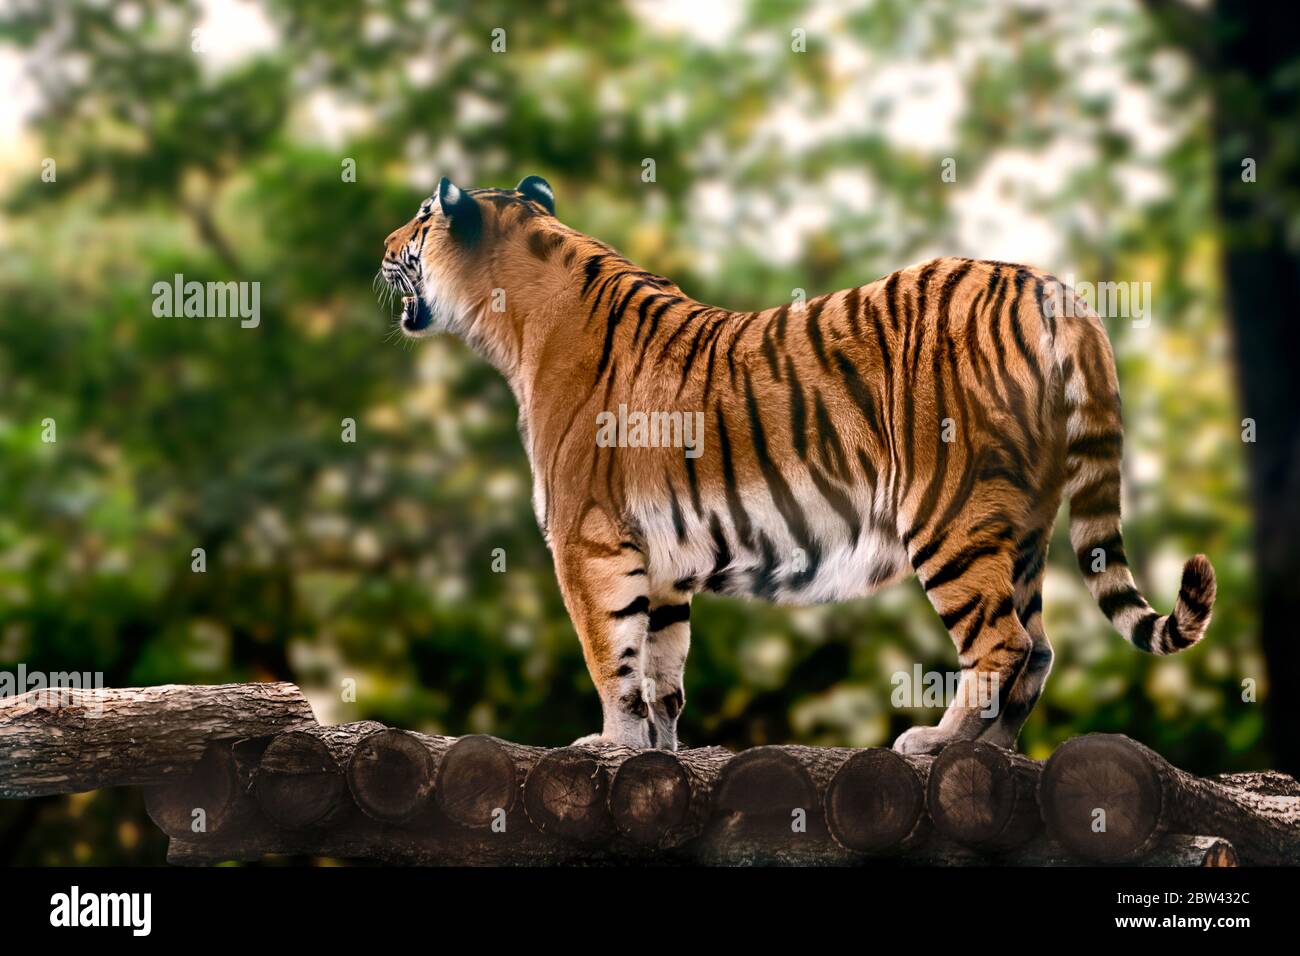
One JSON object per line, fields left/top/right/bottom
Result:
{"left": 381, "top": 176, "right": 555, "bottom": 338}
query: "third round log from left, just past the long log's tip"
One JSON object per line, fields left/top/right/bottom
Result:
{"left": 343, "top": 727, "right": 451, "bottom": 823}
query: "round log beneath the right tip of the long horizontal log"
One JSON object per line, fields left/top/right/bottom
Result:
{"left": 252, "top": 721, "right": 384, "bottom": 830}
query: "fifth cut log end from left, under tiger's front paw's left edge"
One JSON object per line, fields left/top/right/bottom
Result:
{"left": 524, "top": 747, "right": 612, "bottom": 843}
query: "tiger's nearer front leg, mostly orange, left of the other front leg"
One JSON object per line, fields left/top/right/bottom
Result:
{"left": 553, "top": 510, "right": 653, "bottom": 748}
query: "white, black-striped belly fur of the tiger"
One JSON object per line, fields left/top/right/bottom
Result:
{"left": 633, "top": 485, "right": 911, "bottom": 605}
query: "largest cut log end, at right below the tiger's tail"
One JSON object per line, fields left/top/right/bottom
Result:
{"left": 1039, "top": 734, "right": 1162, "bottom": 862}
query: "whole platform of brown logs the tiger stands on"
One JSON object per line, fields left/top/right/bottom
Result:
{"left": 0, "top": 683, "right": 1300, "bottom": 866}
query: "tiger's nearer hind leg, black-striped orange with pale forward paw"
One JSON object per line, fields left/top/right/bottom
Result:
{"left": 894, "top": 489, "right": 1034, "bottom": 753}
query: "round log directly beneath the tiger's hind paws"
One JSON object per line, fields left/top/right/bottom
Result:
{"left": 927, "top": 740, "right": 1043, "bottom": 852}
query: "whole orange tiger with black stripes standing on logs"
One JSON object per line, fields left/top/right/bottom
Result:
{"left": 382, "top": 176, "right": 1214, "bottom": 753}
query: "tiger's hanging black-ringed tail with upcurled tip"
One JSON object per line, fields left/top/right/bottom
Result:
{"left": 1056, "top": 280, "right": 1216, "bottom": 654}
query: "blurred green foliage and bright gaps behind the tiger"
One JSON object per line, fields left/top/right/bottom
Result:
{"left": 0, "top": 0, "right": 1300, "bottom": 864}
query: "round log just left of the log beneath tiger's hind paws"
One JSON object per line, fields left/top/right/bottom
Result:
{"left": 823, "top": 747, "right": 933, "bottom": 853}
